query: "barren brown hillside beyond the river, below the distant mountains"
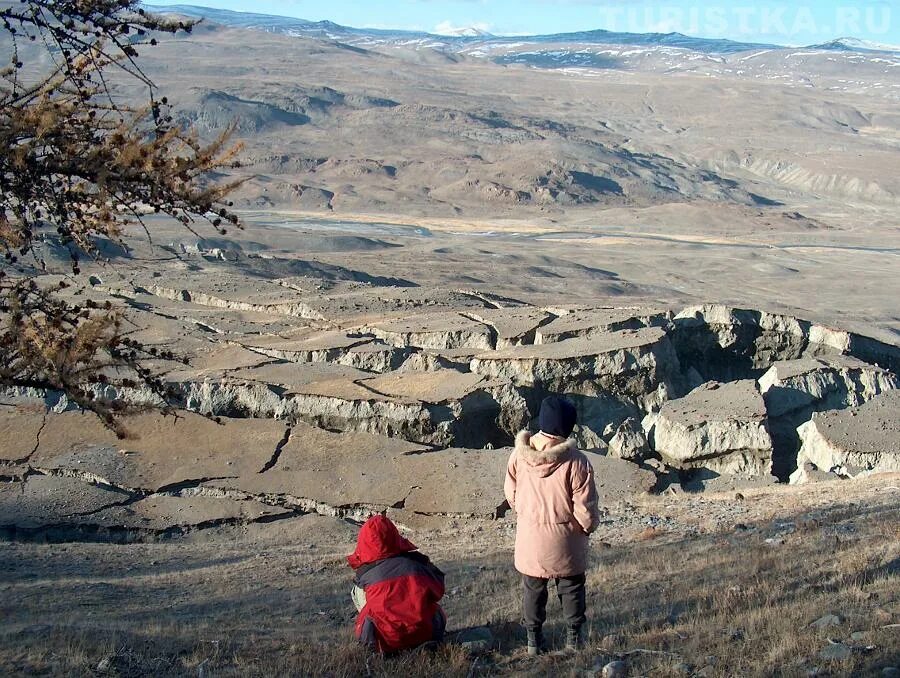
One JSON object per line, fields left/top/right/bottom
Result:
{"left": 132, "top": 8, "right": 900, "bottom": 219}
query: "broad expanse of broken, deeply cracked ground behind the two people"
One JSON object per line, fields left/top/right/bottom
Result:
{"left": 0, "top": 270, "right": 900, "bottom": 540}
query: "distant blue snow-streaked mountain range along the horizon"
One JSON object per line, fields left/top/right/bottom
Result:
{"left": 147, "top": 5, "right": 900, "bottom": 58}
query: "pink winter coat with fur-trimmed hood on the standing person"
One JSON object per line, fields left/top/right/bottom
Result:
{"left": 504, "top": 431, "right": 600, "bottom": 579}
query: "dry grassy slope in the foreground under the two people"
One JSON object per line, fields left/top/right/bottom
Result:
{"left": 0, "top": 502, "right": 900, "bottom": 677}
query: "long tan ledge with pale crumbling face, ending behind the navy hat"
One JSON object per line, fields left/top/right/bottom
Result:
{"left": 162, "top": 362, "right": 528, "bottom": 447}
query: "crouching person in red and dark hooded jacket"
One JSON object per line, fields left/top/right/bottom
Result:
{"left": 347, "top": 516, "right": 447, "bottom": 654}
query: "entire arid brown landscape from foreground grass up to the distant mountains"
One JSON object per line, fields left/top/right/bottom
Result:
{"left": 0, "top": 6, "right": 900, "bottom": 677}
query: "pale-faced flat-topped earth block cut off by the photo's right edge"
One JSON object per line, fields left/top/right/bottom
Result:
{"left": 798, "top": 391, "right": 900, "bottom": 478}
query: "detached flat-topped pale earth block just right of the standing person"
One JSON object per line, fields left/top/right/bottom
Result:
{"left": 642, "top": 380, "right": 772, "bottom": 476}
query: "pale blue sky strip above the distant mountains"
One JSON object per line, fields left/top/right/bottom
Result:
{"left": 148, "top": 0, "right": 900, "bottom": 45}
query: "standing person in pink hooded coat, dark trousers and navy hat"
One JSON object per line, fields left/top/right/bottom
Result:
{"left": 504, "top": 396, "right": 600, "bottom": 655}
